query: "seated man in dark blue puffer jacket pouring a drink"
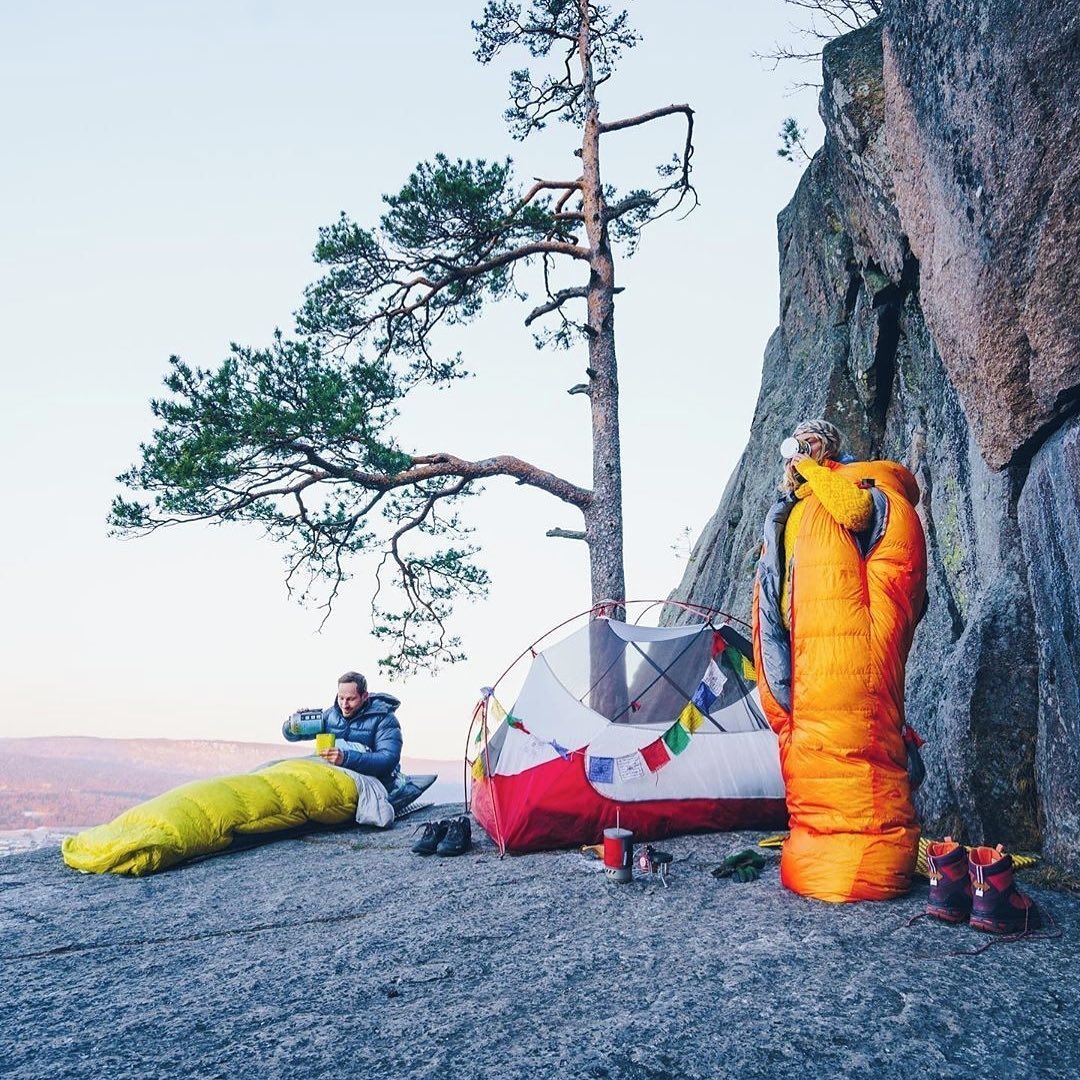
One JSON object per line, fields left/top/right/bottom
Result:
{"left": 281, "top": 672, "right": 402, "bottom": 792}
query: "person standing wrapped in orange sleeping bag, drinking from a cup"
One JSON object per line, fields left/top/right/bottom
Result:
{"left": 753, "top": 420, "right": 927, "bottom": 903}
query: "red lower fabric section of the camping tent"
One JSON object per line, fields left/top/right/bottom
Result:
{"left": 472, "top": 754, "right": 787, "bottom": 851}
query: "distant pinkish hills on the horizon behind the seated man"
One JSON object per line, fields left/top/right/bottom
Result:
{"left": 0, "top": 735, "right": 463, "bottom": 829}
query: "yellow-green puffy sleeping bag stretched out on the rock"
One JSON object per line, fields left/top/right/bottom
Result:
{"left": 62, "top": 759, "right": 356, "bottom": 876}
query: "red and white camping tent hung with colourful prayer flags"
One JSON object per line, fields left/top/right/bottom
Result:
{"left": 472, "top": 618, "right": 787, "bottom": 852}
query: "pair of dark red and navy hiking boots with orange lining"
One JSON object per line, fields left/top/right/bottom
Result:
{"left": 927, "top": 836, "right": 1042, "bottom": 934}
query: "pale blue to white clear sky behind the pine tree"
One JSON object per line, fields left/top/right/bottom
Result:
{"left": 0, "top": 0, "right": 821, "bottom": 758}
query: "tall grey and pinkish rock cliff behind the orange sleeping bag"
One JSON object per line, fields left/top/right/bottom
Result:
{"left": 676, "top": 0, "right": 1080, "bottom": 872}
